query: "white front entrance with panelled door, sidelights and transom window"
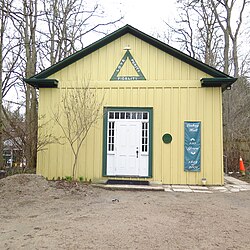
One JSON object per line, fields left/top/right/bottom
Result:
{"left": 107, "top": 111, "right": 149, "bottom": 177}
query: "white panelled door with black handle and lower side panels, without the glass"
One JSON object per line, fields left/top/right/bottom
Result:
{"left": 107, "top": 120, "right": 148, "bottom": 176}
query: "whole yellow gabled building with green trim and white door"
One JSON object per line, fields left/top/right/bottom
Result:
{"left": 25, "top": 25, "right": 236, "bottom": 185}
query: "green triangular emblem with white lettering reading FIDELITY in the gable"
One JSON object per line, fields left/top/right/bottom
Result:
{"left": 110, "top": 49, "right": 146, "bottom": 81}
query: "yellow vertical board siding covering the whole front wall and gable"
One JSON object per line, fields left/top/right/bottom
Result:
{"left": 37, "top": 34, "right": 223, "bottom": 184}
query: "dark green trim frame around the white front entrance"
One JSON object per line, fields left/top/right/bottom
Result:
{"left": 102, "top": 107, "right": 153, "bottom": 178}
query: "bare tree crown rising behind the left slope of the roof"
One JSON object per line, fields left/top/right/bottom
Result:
{"left": 39, "top": 0, "right": 122, "bottom": 65}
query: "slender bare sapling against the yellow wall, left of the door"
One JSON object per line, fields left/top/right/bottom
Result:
{"left": 53, "top": 80, "right": 103, "bottom": 179}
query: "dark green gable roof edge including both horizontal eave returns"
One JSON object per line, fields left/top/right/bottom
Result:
{"left": 25, "top": 24, "right": 237, "bottom": 88}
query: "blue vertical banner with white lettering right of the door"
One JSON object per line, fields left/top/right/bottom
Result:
{"left": 184, "top": 122, "right": 201, "bottom": 172}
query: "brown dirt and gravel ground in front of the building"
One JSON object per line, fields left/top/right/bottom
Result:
{"left": 0, "top": 175, "right": 250, "bottom": 250}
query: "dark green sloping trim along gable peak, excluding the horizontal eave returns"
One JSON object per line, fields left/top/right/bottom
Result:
{"left": 25, "top": 25, "right": 235, "bottom": 87}
